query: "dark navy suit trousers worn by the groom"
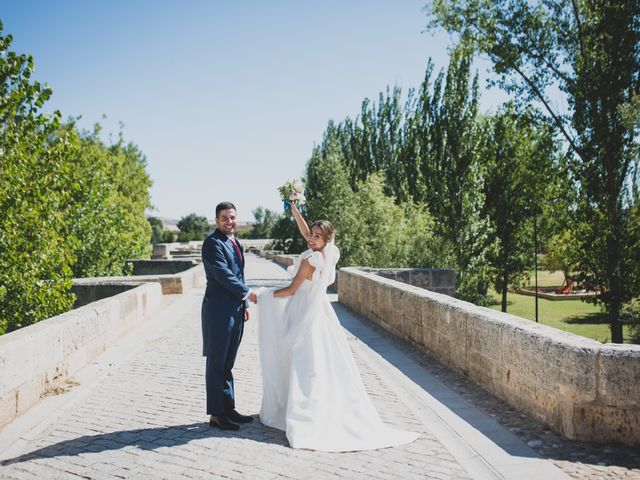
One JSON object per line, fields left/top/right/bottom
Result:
{"left": 205, "top": 310, "right": 244, "bottom": 416}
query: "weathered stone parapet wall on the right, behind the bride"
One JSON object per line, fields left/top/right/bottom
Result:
{"left": 339, "top": 268, "right": 640, "bottom": 444}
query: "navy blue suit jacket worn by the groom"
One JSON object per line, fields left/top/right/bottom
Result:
{"left": 202, "top": 229, "right": 249, "bottom": 355}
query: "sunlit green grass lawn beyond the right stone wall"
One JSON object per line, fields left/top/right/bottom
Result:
{"left": 489, "top": 272, "right": 631, "bottom": 343}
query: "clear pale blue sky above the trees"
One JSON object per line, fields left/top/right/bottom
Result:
{"left": 0, "top": 0, "right": 506, "bottom": 221}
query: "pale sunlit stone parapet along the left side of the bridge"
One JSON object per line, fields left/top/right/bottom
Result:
{"left": 0, "top": 260, "right": 205, "bottom": 427}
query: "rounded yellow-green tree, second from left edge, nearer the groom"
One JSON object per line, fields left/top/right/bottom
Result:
{"left": 67, "top": 124, "right": 151, "bottom": 277}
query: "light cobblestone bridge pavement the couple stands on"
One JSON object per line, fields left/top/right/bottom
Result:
{"left": 0, "top": 253, "right": 640, "bottom": 480}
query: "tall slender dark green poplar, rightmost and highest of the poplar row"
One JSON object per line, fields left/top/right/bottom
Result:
{"left": 417, "top": 46, "right": 491, "bottom": 305}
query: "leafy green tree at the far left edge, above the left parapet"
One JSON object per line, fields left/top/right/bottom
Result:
{"left": 0, "top": 22, "right": 77, "bottom": 333}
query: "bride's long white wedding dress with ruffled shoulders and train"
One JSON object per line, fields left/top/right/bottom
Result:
{"left": 258, "top": 242, "right": 418, "bottom": 452}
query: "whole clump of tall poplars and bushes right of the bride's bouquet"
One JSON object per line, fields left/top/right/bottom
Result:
{"left": 300, "top": 48, "right": 490, "bottom": 303}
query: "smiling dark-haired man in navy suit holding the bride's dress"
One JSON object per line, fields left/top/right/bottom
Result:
{"left": 202, "top": 202, "right": 257, "bottom": 430}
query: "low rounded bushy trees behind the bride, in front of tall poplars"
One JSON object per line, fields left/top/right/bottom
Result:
{"left": 298, "top": 137, "right": 437, "bottom": 267}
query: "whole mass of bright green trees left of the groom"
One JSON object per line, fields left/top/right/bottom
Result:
{"left": 0, "top": 23, "right": 151, "bottom": 334}
